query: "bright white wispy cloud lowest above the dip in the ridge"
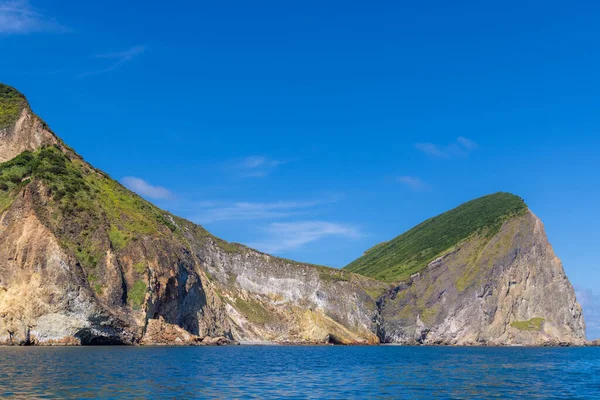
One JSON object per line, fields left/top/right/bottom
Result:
{"left": 248, "top": 221, "right": 363, "bottom": 254}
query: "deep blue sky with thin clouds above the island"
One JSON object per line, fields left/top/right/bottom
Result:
{"left": 0, "top": 0, "right": 600, "bottom": 339}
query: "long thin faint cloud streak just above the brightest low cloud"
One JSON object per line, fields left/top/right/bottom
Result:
{"left": 192, "top": 195, "right": 341, "bottom": 224}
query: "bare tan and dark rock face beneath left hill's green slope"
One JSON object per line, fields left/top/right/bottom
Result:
{"left": 0, "top": 177, "right": 231, "bottom": 344}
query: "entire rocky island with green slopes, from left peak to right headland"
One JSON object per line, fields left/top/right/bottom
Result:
{"left": 0, "top": 84, "right": 584, "bottom": 344}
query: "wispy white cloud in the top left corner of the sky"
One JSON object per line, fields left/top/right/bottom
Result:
{"left": 0, "top": 0, "right": 67, "bottom": 35}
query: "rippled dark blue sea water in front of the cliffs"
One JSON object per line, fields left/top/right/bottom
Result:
{"left": 0, "top": 346, "right": 600, "bottom": 399}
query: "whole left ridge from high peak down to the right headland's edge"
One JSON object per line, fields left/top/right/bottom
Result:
{"left": 0, "top": 85, "right": 385, "bottom": 344}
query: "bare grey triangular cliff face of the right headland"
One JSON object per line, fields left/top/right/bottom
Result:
{"left": 379, "top": 211, "right": 585, "bottom": 345}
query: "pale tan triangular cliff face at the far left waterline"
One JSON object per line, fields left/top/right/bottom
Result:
{"left": 0, "top": 186, "right": 131, "bottom": 344}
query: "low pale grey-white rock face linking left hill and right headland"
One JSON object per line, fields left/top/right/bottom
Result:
{"left": 191, "top": 234, "right": 388, "bottom": 344}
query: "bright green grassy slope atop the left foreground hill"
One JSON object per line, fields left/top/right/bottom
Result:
{"left": 0, "top": 147, "right": 174, "bottom": 267}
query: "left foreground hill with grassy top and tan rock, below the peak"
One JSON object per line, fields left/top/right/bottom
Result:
{"left": 0, "top": 146, "right": 230, "bottom": 343}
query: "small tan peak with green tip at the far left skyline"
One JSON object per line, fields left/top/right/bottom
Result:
{"left": 0, "top": 83, "right": 60, "bottom": 162}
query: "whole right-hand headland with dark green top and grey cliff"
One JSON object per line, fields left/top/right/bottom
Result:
{"left": 347, "top": 193, "right": 585, "bottom": 345}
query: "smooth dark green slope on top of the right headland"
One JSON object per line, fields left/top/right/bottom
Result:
{"left": 345, "top": 193, "right": 527, "bottom": 282}
